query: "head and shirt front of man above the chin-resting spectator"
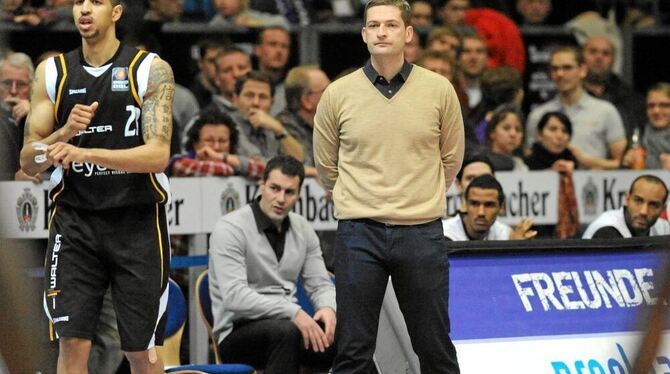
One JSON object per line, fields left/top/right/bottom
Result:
{"left": 254, "top": 26, "right": 291, "bottom": 115}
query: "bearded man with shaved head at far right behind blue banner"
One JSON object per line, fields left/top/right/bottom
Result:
{"left": 582, "top": 174, "right": 670, "bottom": 239}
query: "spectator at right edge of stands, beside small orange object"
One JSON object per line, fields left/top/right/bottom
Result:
{"left": 622, "top": 82, "right": 670, "bottom": 170}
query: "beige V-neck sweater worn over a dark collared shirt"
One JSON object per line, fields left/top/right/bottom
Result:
{"left": 314, "top": 66, "right": 464, "bottom": 225}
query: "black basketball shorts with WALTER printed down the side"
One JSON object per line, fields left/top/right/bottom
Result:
{"left": 44, "top": 204, "right": 170, "bottom": 352}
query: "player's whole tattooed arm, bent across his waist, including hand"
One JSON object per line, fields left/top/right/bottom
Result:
{"left": 48, "top": 58, "right": 174, "bottom": 173}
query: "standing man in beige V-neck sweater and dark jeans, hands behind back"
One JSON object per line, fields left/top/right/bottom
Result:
{"left": 314, "top": 0, "right": 464, "bottom": 374}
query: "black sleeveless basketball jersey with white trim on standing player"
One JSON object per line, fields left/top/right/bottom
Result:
{"left": 45, "top": 44, "right": 169, "bottom": 210}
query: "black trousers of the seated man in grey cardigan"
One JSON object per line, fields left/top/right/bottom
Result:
{"left": 219, "top": 319, "right": 335, "bottom": 374}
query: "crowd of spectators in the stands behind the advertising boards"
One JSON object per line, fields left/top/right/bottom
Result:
{"left": 0, "top": 0, "right": 670, "bottom": 241}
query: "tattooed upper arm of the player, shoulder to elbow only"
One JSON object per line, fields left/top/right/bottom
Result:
{"left": 142, "top": 60, "right": 174, "bottom": 144}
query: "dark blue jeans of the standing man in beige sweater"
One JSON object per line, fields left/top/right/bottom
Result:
{"left": 333, "top": 219, "right": 460, "bottom": 374}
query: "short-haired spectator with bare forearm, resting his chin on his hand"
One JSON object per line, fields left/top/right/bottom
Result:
{"left": 232, "top": 71, "right": 304, "bottom": 161}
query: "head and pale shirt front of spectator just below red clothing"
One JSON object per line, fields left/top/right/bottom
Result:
{"left": 462, "top": 32, "right": 489, "bottom": 109}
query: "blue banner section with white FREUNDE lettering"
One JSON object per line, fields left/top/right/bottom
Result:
{"left": 449, "top": 250, "right": 669, "bottom": 340}
